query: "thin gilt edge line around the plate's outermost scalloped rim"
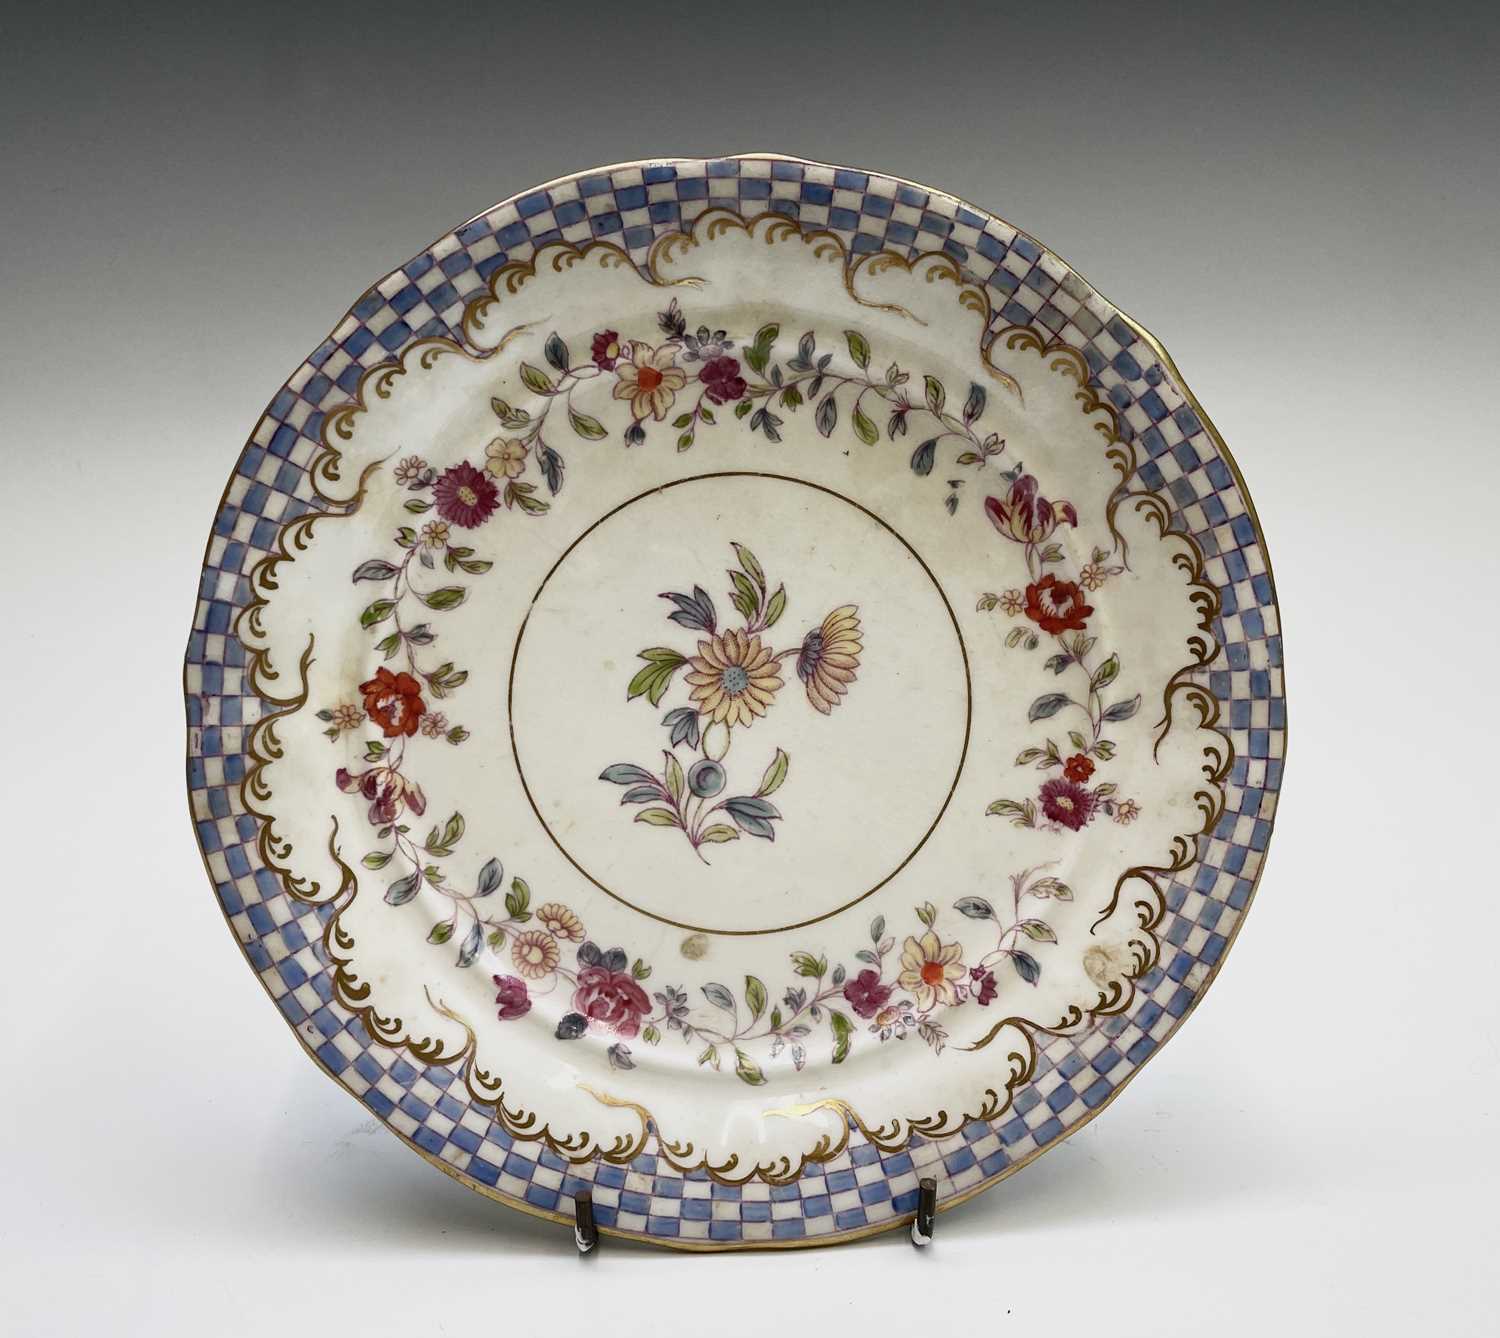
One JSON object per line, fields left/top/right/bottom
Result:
{"left": 182, "top": 152, "right": 1289, "bottom": 1253}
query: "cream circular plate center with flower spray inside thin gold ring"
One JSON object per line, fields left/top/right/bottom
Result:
{"left": 509, "top": 473, "right": 971, "bottom": 935}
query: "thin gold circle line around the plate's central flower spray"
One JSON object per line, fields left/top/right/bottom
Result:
{"left": 506, "top": 470, "right": 974, "bottom": 938}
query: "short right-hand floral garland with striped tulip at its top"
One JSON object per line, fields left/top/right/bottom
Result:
{"left": 978, "top": 467, "right": 1140, "bottom": 831}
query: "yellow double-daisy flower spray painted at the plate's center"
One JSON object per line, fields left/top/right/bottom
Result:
{"left": 599, "top": 543, "right": 864, "bottom": 864}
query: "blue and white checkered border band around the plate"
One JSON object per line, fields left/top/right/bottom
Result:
{"left": 185, "top": 155, "right": 1286, "bottom": 1248}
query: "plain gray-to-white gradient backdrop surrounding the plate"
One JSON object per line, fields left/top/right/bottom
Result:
{"left": 0, "top": 0, "right": 1500, "bottom": 1335}
